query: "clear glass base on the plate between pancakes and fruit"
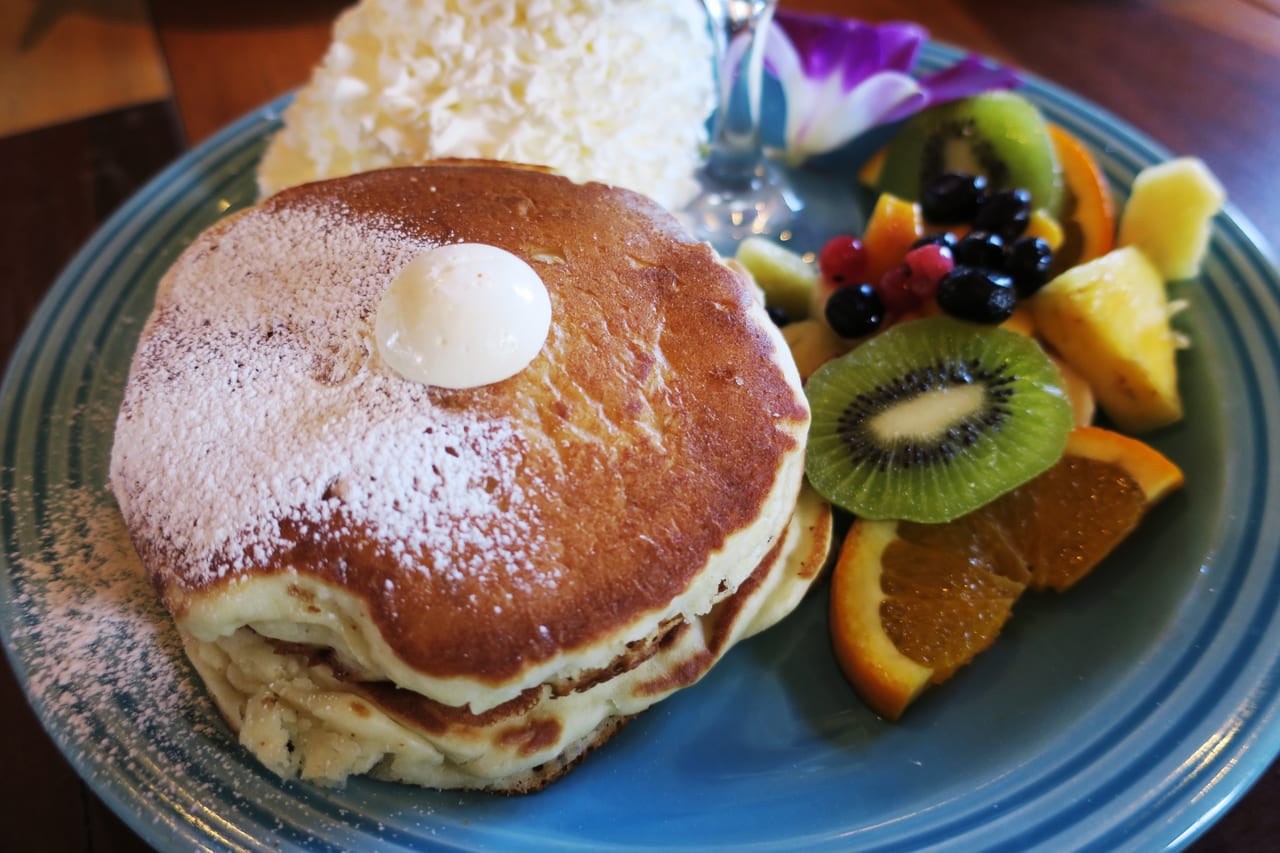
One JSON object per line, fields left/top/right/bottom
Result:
{"left": 684, "top": 160, "right": 804, "bottom": 257}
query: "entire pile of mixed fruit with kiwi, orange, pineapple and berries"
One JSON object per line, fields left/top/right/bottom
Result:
{"left": 768, "top": 26, "right": 1222, "bottom": 719}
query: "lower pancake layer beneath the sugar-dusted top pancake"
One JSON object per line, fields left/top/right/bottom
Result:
{"left": 183, "top": 487, "right": 831, "bottom": 793}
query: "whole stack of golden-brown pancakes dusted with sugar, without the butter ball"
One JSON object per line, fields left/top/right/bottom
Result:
{"left": 111, "top": 163, "right": 831, "bottom": 792}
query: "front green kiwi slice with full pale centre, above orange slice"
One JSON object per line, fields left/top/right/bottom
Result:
{"left": 805, "top": 316, "right": 1073, "bottom": 524}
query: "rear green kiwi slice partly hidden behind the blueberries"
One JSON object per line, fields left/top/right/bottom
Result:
{"left": 878, "top": 91, "right": 1062, "bottom": 216}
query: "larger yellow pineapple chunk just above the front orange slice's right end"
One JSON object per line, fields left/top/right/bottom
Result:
{"left": 1030, "top": 246, "right": 1183, "bottom": 433}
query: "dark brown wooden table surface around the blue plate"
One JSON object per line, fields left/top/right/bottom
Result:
{"left": 0, "top": 0, "right": 1280, "bottom": 853}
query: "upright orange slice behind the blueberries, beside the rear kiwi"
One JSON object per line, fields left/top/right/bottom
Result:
{"left": 1048, "top": 124, "right": 1116, "bottom": 270}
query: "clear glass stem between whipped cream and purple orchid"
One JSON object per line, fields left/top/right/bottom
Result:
{"left": 705, "top": 0, "right": 777, "bottom": 190}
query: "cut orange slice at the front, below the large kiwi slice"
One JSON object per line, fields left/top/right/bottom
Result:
{"left": 831, "top": 427, "right": 1183, "bottom": 720}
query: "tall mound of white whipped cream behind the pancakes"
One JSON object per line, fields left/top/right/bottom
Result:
{"left": 257, "top": 0, "right": 714, "bottom": 209}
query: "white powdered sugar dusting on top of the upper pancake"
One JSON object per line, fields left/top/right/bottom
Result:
{"left": 111, "top": 198, "right": 553, "bottom": 588}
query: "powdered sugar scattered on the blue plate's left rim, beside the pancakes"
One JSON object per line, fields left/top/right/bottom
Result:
{"left": 0, "top": 473, "right": 455, "bottom": 850}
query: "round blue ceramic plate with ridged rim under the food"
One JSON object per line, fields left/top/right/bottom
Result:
{"left": 0, "top": 46, "right": 1280, "bottom": 850}
